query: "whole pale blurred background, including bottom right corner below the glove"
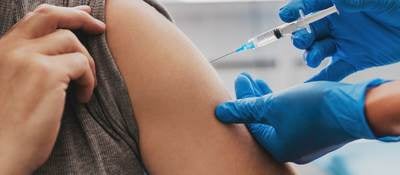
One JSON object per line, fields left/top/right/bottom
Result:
{"left": 160, "top": 0, "right": 400, "bottom": 175}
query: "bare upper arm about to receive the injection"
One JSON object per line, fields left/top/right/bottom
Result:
{"left": 106, "top": 0, "right": 292, "bottom": 174}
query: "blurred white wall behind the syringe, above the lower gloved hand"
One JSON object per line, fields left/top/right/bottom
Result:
{"left": 162, "top": 1, "right": 400, "bottom": 93}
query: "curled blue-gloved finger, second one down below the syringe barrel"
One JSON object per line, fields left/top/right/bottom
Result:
{"left": 304, "top": 38, "right": 336, "bottom": 68}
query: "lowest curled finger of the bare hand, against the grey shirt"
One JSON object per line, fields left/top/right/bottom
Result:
{"left": 51, "top": 52, "right": 95, "bottom": 103}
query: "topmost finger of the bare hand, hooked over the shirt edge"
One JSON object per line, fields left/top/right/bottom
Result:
{"left": 19, "top": 5, "right": 105, "bottom": 38}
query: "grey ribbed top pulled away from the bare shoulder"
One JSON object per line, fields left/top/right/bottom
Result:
{"left": 0, "top": 0, "right": 171, "bottom": 175}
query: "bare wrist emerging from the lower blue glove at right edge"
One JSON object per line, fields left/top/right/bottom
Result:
{"left": 365, "top": 81, "right": 400, "bottom": 136}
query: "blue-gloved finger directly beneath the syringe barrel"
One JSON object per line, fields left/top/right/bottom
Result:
{"left": 292, "top": 19, "right": 330, "bottom": 49}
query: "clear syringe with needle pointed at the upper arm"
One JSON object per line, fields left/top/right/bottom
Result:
{"left": 210, "top": 6, "right": 338, "bottom": 64}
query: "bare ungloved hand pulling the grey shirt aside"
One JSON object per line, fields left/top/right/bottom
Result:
{"left": 0, "top": 5, "right": 105, "bottom": 174}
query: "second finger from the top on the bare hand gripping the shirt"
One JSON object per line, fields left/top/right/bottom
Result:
{"left": 33, "top": 29, "right": 96, "bottom": 82}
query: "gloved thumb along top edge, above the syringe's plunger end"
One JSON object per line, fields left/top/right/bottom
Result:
{"left": 332, "top": 0, "right": 400, "bottom": 12}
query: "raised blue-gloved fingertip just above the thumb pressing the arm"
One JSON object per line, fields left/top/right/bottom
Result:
{"left": 235, "top": 73, "right": 257, "bottom": 99}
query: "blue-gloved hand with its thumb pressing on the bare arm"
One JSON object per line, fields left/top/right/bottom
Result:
{"left": 216, "top": 74, "right": 397, "bottom": 164}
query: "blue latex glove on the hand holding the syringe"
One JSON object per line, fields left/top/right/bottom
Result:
{"left": 279, "top": 0, "right": 400, "bottom": 81}
